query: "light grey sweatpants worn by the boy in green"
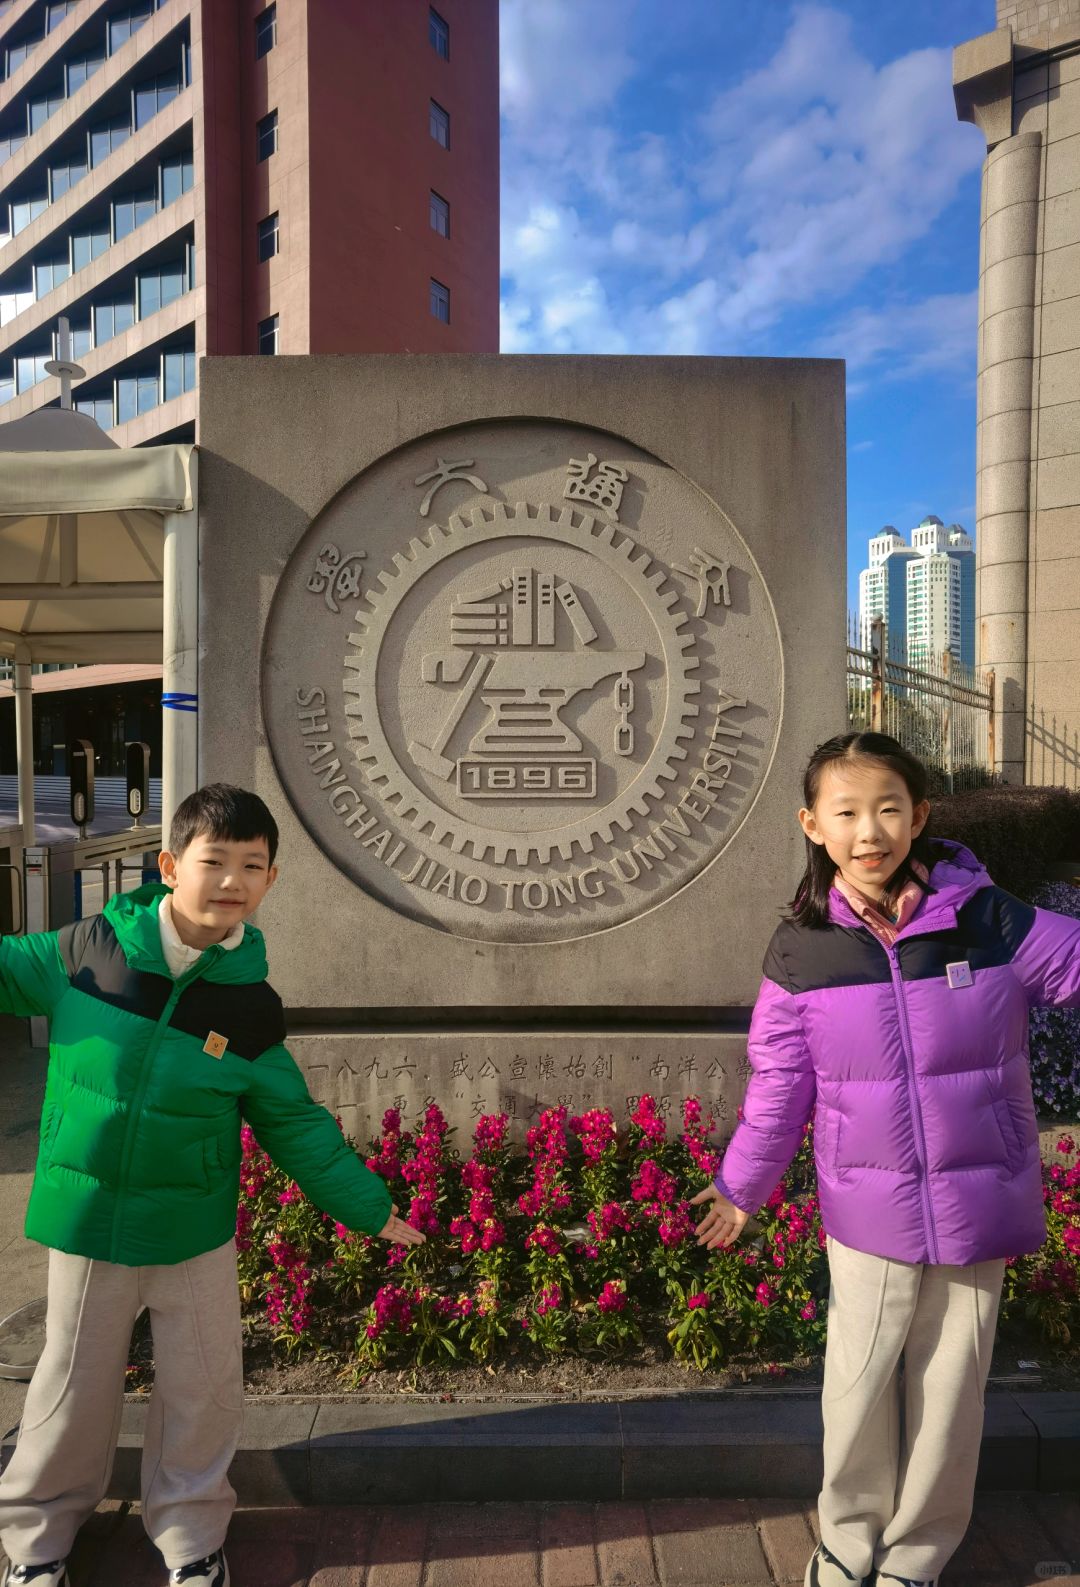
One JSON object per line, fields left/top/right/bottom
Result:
{"left": 0, "top": 1241, "right": 244, "bottom": 1570}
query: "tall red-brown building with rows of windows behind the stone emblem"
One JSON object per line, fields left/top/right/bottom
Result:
{"left": 0, "top": 0, "right": 498, "bottom": 446}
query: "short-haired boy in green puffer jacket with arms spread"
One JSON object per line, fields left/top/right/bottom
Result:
{"left": 0, "top": 782, "right": 423, "bottom": 1587}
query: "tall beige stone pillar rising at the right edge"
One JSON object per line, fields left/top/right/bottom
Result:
{"left": 953, "top": 0, "right": 1080, "bottom": 787}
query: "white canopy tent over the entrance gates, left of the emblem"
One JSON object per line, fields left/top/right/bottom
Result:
{"left": 0, "top": 408, "right": 198, "bottom": 844}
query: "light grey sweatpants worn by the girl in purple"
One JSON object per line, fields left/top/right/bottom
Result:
{"left": 818, "top": 1238, "right": 1005, "bottom": 1581}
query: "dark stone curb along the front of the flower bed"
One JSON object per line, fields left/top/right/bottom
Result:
{"left": 0, "top": 1392, "right": 1080, "bottom": 1508}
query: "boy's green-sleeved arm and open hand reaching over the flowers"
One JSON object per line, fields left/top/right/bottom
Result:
{"left": 241, "top": 1046, "right": 423, "bottom": 1246}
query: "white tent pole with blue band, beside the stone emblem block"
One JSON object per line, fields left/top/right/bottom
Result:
{"left": 162, "top": 449, "right": 198, "bottom": 843}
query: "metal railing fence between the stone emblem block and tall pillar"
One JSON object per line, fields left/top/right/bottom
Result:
{"left": 847, "top": 616, "right": 994, "bottom": 794}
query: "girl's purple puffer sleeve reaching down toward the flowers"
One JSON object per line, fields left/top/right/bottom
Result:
{"left": 714, "top": 976, "right": 817, "bottom": 1212}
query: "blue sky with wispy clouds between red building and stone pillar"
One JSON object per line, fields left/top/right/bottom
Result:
{"left": 500, "top": 0, "right": 994, "bottom": 606}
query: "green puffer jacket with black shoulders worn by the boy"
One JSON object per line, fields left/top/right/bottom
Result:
{"left": 0, "top": 886, "right": 390, "bottom": 1266}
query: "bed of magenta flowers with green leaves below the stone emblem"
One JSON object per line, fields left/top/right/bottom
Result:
{"left": 236, "top": 1097, "right": 1080, "bottom": 1387}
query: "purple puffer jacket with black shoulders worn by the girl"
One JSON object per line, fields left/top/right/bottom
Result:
{"left": 715, "top": 843, "right": 1080, "bottom": 1263}
